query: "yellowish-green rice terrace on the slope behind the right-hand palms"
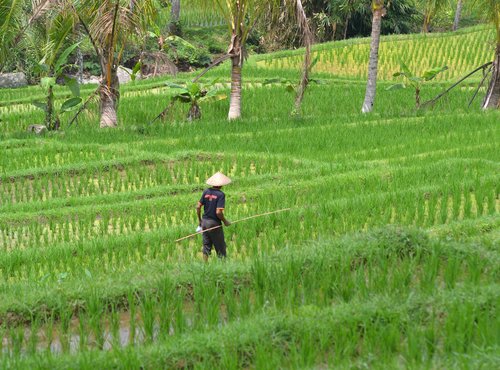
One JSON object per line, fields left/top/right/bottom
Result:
{"left": 257, "top": 26, "right": 495, "bottom": 81}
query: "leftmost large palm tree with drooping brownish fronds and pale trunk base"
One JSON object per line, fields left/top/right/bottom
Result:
{"left": 69, "top": 0, "right": 156, "bottom": 127}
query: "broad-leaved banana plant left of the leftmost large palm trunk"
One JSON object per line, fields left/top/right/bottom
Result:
{"left": 32, "top": 43, "right": 82, "bottom": 131}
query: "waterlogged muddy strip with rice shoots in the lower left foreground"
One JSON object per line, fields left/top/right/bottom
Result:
{"left": 0, "top": 302, "right": 219, "bottom": 356}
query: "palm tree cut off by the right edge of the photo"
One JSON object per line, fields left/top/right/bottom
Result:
{"left": 478, "top": 0, "right": 500, "bottom": 109}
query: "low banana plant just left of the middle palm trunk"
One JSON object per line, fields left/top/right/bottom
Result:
{"left": 162, "top": 80, "right": 227, "bottom": 121}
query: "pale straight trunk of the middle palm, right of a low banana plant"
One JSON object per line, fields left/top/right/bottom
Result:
{"left": 227, "top": 34, "right": 243, "bottom": 120}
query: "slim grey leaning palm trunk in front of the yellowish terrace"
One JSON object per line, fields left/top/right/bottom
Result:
{"left": 361, "top": 5, "right": 385, "bottom": 113}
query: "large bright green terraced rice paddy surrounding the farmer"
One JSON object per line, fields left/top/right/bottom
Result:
{"left": 0, "top": 25, "right": 500, "bottom": 369}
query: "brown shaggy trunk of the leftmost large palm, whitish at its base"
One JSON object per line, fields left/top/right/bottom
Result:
{"left": 99, "top": 53, "right": 120, "bottom": 128}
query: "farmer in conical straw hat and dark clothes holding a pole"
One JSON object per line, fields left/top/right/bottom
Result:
{"left": 196, "top": 172, "right": 231, "bottom": 261}
